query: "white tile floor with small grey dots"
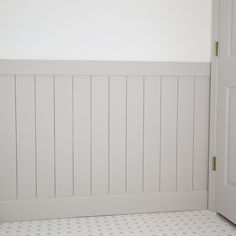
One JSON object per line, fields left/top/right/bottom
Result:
{"left": 0, "top": 211, "right": 236, "bottom": 236}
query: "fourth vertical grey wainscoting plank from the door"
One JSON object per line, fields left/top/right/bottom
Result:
{"left": 143, "top": 77, "right": 161, "bottom": 192}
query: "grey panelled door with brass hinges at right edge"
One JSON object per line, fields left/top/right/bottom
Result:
{"left": 216, "top": 0, "right": 236, "bottom": 223}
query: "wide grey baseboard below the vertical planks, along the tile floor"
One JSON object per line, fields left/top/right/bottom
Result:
{"left": 0, "top": 191, "right": 207, "bottom": 222}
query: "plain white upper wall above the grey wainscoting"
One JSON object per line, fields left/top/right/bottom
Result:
{"left": 0, "top": 0, "right": 211, "bottom": 62}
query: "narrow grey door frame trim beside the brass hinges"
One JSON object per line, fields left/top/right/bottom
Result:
{"left": 208, "top": 0, "right": 220, "bottom": 211}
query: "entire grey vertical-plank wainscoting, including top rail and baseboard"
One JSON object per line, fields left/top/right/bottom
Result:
{"left": 0, "top": 61, "right": 209, "bottom": 220}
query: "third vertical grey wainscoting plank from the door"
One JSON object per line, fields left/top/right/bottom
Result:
{"left": 160, "top": 77, "right": 178, "bottom": 192}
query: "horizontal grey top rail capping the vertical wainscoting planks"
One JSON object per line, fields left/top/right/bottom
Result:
{"left": 0, "top": 60, "right": 210, "bottom": 76}
